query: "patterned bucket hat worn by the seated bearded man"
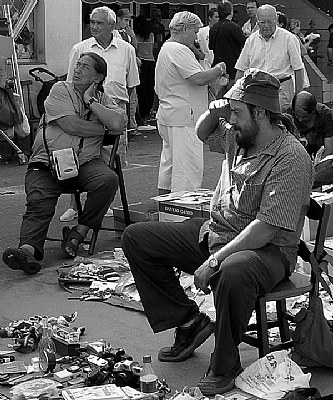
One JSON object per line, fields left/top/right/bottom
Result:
{"left": 224, "top": 68, "right": 281, "bottom": 114}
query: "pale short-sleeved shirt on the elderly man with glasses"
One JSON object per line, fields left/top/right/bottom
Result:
{"left": 235, "top": 26, "right": 304, "bottom": 79}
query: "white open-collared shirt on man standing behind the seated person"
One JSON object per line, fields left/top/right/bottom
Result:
{"left": 67, "top": 36, "right": 140, "bottom": 102}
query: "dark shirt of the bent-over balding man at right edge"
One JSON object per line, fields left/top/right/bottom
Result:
{"left": 294, "top": 103, "right": 333, "bottom": 156}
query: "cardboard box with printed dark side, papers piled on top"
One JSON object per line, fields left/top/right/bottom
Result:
{"left": 153, "top": 189, "right": 213, "bottom": 222}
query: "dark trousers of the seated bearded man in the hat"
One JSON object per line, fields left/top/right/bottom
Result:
{"left": 122, "top": 219, "right": 288, "bottom": 374}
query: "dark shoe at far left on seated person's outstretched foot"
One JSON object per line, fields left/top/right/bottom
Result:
{"left": 2, "top": 247, "right": 41, "bottom": 275}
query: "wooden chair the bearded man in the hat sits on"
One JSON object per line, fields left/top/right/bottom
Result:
{"left": 243, "top": 199, "right": 331, "bottom": 357}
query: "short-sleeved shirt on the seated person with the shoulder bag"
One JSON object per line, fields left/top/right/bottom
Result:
{"left": 29, "top": 82, "right": 126, "bottom": 165}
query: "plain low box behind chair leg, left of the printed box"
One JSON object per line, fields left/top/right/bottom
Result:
{"left": 113, "top": 200, "right": 158, "bottom": 230}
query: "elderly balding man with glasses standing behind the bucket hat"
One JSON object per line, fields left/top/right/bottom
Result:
{"left": 235, "top": 4, "right": 304, "bottom": 111}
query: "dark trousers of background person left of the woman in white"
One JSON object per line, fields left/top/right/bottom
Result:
{"left": 136, "top": 60, "right": 155, "bottom": 118}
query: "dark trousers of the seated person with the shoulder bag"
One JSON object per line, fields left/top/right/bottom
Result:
{"left": 19, "top": 159, "right": 118, "bottom": 260}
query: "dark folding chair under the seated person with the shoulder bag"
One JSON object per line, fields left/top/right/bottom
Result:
{"left": 46, "top": 135, "right": 131, "bottom": 255}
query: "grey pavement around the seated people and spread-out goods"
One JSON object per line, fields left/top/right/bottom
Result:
{"left": 0, "top": 131, "right": 333, "bottom": 395}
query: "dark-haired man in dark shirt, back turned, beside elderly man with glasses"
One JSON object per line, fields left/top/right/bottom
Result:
{"left": 209, "top": 1, "right": 245, "bottom": 98}
